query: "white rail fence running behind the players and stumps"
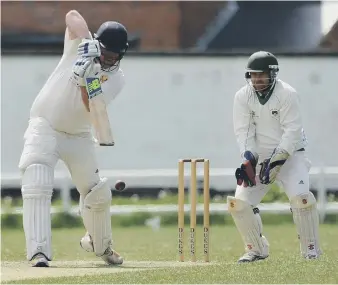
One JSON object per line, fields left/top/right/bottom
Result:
{"left": 1, "top": 167, "right": 338, "bottom": 221}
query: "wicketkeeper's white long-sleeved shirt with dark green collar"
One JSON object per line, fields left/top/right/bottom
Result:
{"left": 233, "top": 80, "right": 307, "bottom": 161}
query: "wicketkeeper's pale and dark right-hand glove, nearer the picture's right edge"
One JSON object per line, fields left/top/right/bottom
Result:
{"left": 259, "top": 148, "right": 290, "bottom": 184}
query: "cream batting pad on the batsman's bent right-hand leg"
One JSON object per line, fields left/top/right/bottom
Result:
{"left": 82, "top": 178, "right": 112, "bottom": 256}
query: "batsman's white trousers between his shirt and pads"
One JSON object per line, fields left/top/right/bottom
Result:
{"left": 19, "top": 118, "right": 100, "bottom": 196}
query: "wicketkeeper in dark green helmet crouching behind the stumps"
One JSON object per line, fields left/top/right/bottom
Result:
{"left": 227, "top": 51, "right": 321, "bottom": 263}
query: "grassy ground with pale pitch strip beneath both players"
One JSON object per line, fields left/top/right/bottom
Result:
{"left": 1, "top": 224, "right": 338, "bottom": 284}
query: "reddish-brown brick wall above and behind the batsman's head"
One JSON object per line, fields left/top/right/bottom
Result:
{"left": 1, "top": 1, "right": 181, "bottom": 50}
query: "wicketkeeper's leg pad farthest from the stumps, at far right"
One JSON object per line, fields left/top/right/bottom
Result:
{"left": 290, "top": 192, "right": 321, "bottom": 258}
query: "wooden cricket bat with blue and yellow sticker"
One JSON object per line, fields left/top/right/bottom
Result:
{"left": 81, "top": 35, "right": 115, "bottom": 146}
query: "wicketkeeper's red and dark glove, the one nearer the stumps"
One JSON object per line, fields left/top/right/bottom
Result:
{"left": 235, "top": 150, "right": 258, "bottom": 187}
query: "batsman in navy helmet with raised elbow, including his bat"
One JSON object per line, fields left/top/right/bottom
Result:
{"left": 19, "top": 10, "right": 128, "bottom": 267}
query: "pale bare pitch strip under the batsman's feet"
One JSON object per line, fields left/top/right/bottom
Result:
{"left": 1, "top": 261, "right": 214, "bottom": 282}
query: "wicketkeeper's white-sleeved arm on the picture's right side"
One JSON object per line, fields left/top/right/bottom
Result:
{"left": 279, "top": 90, "right": 303, "bottom": 155}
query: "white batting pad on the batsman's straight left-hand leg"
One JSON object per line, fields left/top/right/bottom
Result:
{"left": 21, "top": 164, "right": 54, "bottom": 260}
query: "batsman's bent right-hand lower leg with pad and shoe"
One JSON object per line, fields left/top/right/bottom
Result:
{"left": 80, "top": 178, "right": 123, "bottom": 264}
